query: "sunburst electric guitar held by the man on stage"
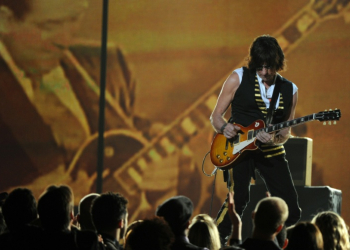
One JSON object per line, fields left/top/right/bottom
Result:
{"left": 210, "top": 109, "right": 341, "bottom": 170}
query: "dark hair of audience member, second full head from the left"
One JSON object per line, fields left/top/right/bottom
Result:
{"left": 38, "top": 185, "right": 73, "bottom": 230}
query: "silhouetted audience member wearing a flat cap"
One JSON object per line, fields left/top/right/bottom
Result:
{"left": 156, "top": 196, "right": 207, "bottom": 250}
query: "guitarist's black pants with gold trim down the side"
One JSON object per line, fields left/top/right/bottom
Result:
{"left": 216, "top": 149, "right": 301, "bottom": 239}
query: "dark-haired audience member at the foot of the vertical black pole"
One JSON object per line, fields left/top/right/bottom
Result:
{"left": 91, "top": 192, "right": 128, "bottom": 250}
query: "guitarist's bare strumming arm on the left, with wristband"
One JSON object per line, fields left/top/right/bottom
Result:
{"left": 210, "top": 72, "right": 240, "bottom": 138}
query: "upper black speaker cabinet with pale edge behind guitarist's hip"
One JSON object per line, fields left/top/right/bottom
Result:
{"left": 255, "top": 137, "right": 312, "bottom": 186}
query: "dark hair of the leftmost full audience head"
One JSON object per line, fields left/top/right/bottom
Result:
{"left": 2, "top": 188, "right": 38, "bottom": 230}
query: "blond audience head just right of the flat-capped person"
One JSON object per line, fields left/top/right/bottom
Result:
{"left": 188, "top": 214, "right": 221, "bottom": 250}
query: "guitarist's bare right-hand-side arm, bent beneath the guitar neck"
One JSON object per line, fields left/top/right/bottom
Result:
{"left": 256, "top": 92, "right": 298, "bottom": 145}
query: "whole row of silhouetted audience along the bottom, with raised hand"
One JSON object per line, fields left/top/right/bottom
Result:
{"left": 0, "top": 185, "right": 350, "bottom": 250}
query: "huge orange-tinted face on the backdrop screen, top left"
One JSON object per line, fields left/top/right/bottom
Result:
{"left": 2, "top": 0, "right": 88, "bottom": 75}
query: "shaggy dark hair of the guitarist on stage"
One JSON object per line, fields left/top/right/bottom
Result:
{"left": 248, "top": 35, "right": 286, "bottom": 73}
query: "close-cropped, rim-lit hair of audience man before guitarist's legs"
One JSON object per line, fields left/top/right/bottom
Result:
{"left": 254, "top": 197, "right": 288, "bottom": 235}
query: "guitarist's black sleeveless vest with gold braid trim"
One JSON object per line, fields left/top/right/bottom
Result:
{"left": 230, "top": 67, "right": 293, "bottom": 158}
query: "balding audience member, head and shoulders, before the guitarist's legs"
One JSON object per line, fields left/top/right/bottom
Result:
{"left": 232, "top": 197, "right": 288, "bottom": 250}
